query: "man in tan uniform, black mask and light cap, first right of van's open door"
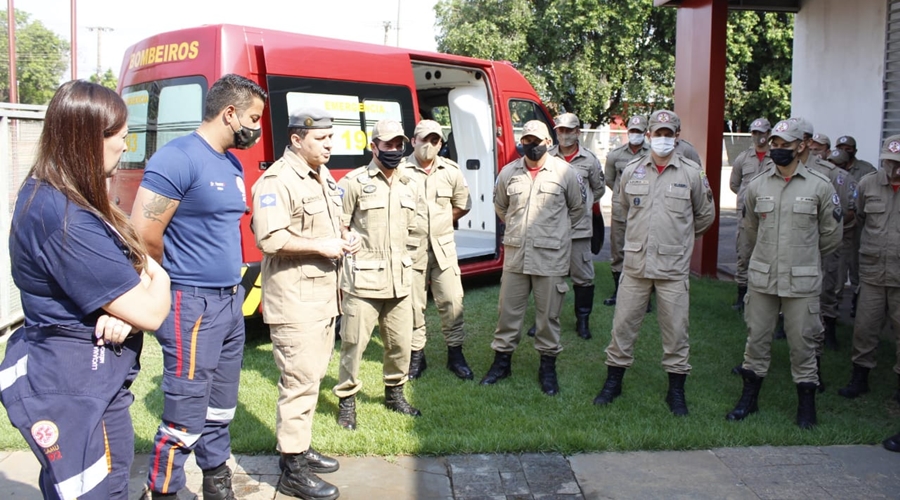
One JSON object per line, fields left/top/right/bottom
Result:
{"left": 481, "top": 120, "right": 588, "bottom": 396}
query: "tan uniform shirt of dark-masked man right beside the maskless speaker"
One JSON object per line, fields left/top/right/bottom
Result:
{"left": 338, "top": 161, "right": 419, "bottom": 299}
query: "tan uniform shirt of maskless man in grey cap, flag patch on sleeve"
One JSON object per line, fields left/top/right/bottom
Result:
{"left": 251, "top": 148, "right": 341, "bottom": 324}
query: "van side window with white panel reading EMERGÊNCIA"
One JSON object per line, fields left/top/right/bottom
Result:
{"left": 267, "top": 76, "right": 416, "bottom": 170}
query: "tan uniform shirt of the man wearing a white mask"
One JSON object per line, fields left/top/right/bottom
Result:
{"left": 619, "top": 153, "right": 716, "bottom": 279}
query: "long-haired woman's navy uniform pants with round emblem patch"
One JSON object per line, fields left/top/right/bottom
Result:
{"left": 0, "top": 327, "right": 143, "bottom": 500}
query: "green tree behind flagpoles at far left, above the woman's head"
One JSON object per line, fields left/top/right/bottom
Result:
{"left": 0, "top": 9, "right": 69, "bottom": 104}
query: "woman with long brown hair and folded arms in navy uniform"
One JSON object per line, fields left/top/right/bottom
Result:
{"left": 0, "top": 80, "right": 170, "bottom": 500}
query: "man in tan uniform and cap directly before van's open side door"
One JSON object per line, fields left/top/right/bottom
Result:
{"left": 400, "top": 120, "right": 474, "bottom": 380}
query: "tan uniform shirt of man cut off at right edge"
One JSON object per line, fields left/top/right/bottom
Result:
{"left": 857, "top": 169, "right": 900, "bottom": 287}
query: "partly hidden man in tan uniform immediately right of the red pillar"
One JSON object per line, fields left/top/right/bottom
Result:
{"left": 728, "top": 118, "right": 772, "bottom": 311}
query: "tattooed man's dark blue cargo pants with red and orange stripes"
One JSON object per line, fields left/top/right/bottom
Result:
{"left": 149, "top": 285, "right": 244, "bottom": 493}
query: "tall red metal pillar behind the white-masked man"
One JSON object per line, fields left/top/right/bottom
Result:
{"left": 675, "top": 0, "right": 728, "bottom": 277}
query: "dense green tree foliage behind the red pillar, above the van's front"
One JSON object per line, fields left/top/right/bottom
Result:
{"left": 435, "top": 0, "right": 793, "bottom": 130}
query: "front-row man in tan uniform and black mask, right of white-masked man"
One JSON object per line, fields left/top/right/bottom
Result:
{"left": 726, "top": 120, "right": 843, "bottom": 429}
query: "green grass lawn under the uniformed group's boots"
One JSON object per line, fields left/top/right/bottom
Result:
{"left": 0, "top": 263, "right": 900, "bottom": 455}
